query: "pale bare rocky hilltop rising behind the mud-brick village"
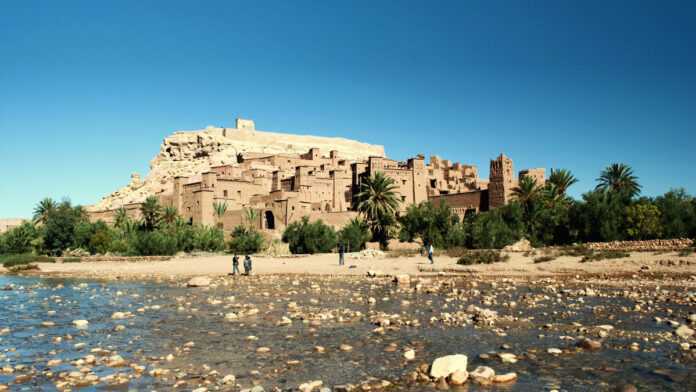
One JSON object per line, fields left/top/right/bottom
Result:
{"left": 88, "top": 119, "right": 384, "bottom": 211}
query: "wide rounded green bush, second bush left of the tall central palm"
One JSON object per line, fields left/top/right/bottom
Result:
{"left": 283, "top": 216, "right": 336, "bottom": 254}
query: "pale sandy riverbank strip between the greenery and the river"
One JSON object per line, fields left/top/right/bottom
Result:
{"left": 29, "top": 252, "right": 696, "bottom": 280}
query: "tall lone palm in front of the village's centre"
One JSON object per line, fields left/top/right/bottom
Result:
{"left": 356, "top": 172, "right": 399, "bottom": 243}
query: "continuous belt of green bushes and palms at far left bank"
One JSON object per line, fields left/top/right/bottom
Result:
{"left": 0, "top": 198, "right": 225, "bottom": 256}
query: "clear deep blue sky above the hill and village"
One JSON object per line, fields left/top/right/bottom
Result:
{"left": 0, "top": 0, "right": 696, "bottom": 217}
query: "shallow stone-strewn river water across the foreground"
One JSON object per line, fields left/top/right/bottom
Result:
{"left": 0, "top": 276, "right": 696, "bottom": 391}
